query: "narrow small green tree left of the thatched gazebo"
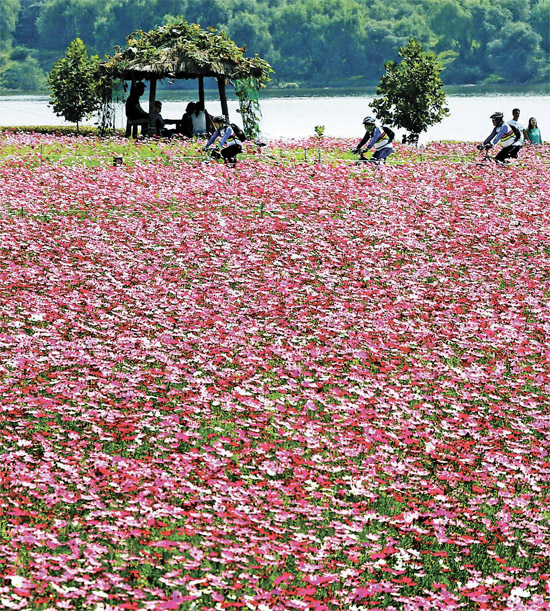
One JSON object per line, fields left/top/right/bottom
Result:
{"left": 48, "top": 38, "right": 101, "bottom": 132}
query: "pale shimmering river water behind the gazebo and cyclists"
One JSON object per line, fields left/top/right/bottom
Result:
{"left": 0, "top": 86, "right": 550, "bottom": 141}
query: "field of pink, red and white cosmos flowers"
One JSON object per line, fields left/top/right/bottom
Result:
{"left": 0, "top": 134, "right": 550, "bottom": 611}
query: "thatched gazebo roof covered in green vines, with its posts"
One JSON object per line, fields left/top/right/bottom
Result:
{"left": 99, "top": 19, "right": 272, "bottom": 134}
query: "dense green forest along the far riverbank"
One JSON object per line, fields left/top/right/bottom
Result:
{"left": 0, "top": 0, "right": 550, "bottom": 90}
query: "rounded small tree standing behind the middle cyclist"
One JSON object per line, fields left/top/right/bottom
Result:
{"left": 371, "top": 38, "right": 449, "bottom": 142}
